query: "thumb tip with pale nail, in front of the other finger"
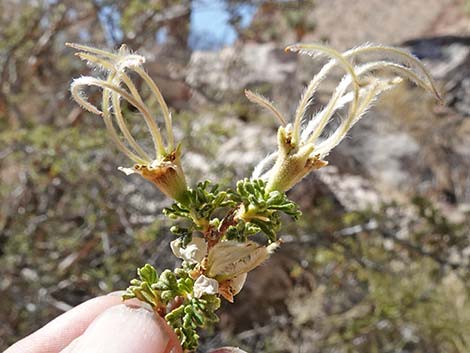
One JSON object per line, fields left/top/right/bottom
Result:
{"left": 62, "top": 304, "right": 182, "bottom": 353}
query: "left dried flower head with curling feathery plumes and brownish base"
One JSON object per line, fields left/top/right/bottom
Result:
{"left": 67, "top": 43, "right": 187, "bottom": 202}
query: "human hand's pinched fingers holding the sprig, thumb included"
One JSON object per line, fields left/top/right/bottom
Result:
{"left": 4, "top": 295, "right": 182, "bottom": 353}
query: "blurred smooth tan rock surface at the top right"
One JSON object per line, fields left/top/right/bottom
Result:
{"left": 305, "top": 0, "right": 458, "bottom": 50}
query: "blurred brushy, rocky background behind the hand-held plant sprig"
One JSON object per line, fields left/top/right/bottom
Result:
{"left": 0, "top": 0, "right": 470, "bottom": 353}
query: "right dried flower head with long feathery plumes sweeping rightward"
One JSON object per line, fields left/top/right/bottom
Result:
{"left": 250, "top": 44, "right": 440, "bottom": 191}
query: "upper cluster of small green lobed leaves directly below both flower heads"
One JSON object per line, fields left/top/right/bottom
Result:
{"left": 163, "top": 179, "right": 301, "bottom": 244}
